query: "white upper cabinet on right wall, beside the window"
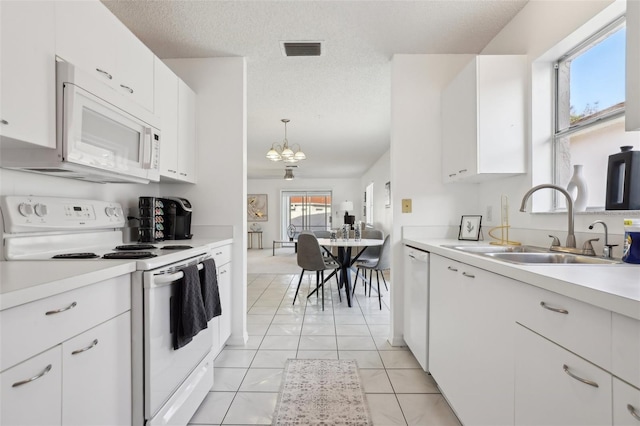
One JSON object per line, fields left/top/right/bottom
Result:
{"left": 441, "top": 55, "right": 527, "bottom": 182}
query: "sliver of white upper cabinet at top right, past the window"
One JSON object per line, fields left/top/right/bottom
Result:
{"left": 625, "top": 0, "right": 640, "bottom": 131}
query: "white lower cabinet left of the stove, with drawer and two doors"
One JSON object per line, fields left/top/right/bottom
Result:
{"left": 0, "top": 275, "right": 132, "bottom": 426}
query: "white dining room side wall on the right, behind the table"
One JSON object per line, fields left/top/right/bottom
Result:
{"left": 360, "top": 150, "right": 393, "bottom": 235}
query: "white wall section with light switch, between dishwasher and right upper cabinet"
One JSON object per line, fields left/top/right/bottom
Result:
{"left": 390, "top": 55, "right": 478, "bottom": 345}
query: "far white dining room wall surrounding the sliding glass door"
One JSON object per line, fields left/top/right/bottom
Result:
{"left": 247, "top": 176, "right": 364, "bottom": 243}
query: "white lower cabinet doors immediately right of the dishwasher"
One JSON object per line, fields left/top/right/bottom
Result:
{"left": 429, "top": 254, "right": 514, "bottom": 425}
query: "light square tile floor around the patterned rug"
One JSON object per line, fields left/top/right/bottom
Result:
{"left": 190, "top": 273, "right": 460, "bottom": 426}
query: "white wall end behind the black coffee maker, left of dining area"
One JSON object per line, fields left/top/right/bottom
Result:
{"left": 162, "top": 58, "right": 247, "bottom": 344}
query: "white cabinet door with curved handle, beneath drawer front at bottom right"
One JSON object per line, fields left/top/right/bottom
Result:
{"left": 515, "top": 325, "right": 612, "bottom": 426}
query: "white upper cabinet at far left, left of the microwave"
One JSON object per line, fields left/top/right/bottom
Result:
{"left": 0, "top": 1, "right": 56, "bottom": 148}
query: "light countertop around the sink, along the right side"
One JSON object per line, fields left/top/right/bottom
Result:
{"left": 403, "top": 238, "right": 640, "bottom": 320}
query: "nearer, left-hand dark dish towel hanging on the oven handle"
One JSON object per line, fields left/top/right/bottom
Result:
{"left": 173, "top": 265, "right": 207, "bottom": 349}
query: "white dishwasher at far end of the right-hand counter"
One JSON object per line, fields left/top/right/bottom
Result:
{"left": 404, "top": 245, "right": 429, "bottom": 371}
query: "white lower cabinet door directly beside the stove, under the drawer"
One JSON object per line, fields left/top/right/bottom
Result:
{"left": 62, "top": 312, "right": 131, "bottom": 426}
